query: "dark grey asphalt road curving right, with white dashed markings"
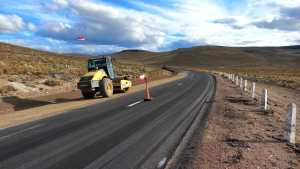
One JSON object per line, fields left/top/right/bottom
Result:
{"left": 0, "top": 72, "right": 215, "bottom": 169}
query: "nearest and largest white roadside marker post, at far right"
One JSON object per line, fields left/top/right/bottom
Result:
{"left": 284, "top": 103, "right": 297, "bottom": 144}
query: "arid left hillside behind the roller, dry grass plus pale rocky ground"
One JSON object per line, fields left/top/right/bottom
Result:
{"left": 0, "top": 43, "right": 147, "bottom": 96}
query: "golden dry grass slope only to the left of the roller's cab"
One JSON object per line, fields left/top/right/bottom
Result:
{"left": 0, "top": 43, "right": 87, "bottom": 77}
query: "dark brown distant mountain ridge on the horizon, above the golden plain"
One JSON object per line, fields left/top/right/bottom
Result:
{"left": 113, "top": 46, "right": 300, "bottom": 68}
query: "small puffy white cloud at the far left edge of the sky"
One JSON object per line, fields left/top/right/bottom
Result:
{"left": 0, "top": 14, "right": 24, "bottom": 33}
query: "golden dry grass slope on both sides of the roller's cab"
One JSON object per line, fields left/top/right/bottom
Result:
{"left": 0, "top": 43, "right": 155, "bottom": 81}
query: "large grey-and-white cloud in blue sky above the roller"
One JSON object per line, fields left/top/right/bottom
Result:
{"left": 39, "top": 0, "right": 168, "bottom": 49}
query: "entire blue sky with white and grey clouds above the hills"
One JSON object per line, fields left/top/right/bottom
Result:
{"left": 0, "top": 0, "right": 300, "bottom": 54}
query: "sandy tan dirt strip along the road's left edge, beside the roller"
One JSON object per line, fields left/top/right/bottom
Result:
{"left": 0, "top": 72, "right": 186, "bottom": 129}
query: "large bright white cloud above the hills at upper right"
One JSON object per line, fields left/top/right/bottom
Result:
{"left": 162, "top": 0, "right": 300, "bottom": 46}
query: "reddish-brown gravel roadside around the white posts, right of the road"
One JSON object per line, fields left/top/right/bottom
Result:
{"left": 181, "top": 76, "right": 300, "bottom": 169}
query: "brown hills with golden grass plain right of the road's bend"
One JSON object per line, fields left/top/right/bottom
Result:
{"left": 114, "top": 46, "right": 300, "bottom": 90}
